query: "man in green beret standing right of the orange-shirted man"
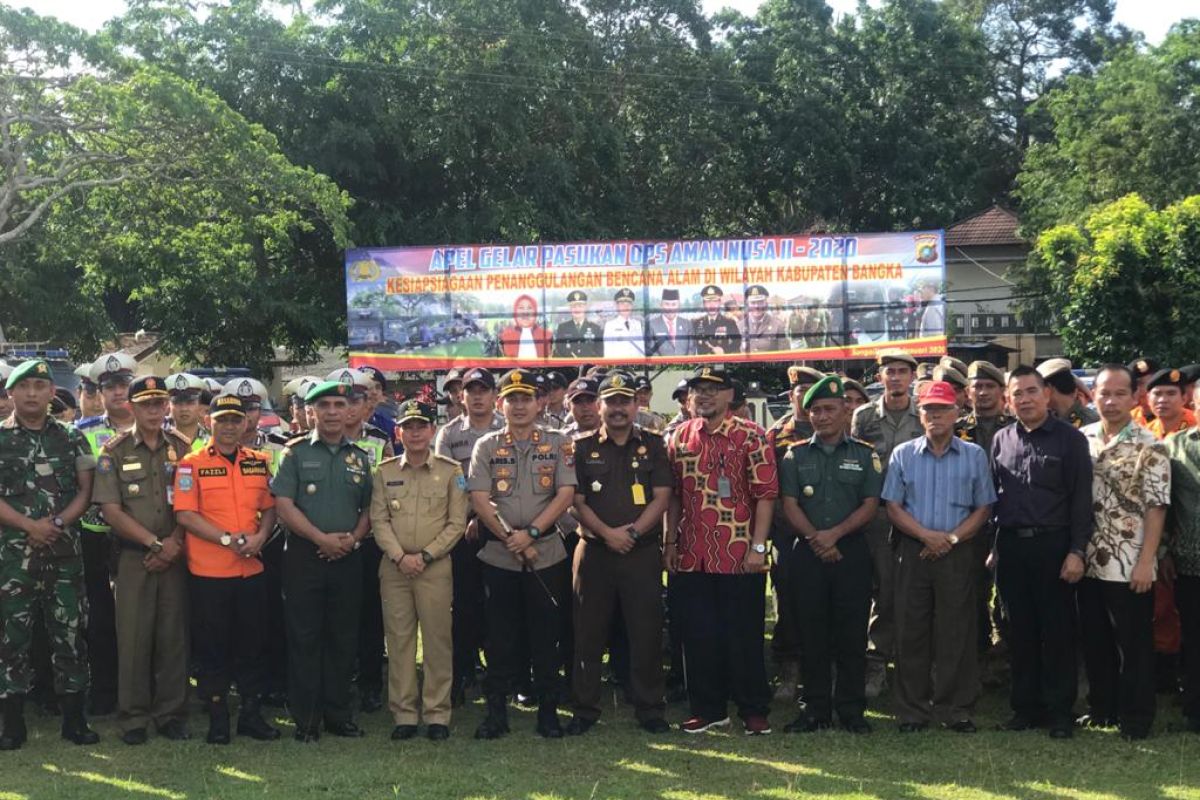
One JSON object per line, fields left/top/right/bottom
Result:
{"left": 271, "top": 380, "right": 371, "bottom": 741}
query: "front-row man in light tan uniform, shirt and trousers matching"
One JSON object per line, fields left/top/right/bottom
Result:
{"left": 371, "top": 401, "right": 467, "bottom": 741}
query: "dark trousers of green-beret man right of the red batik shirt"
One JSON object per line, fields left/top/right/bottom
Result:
{"left": 787, "top": 533, "right": 874, "bottom": 722}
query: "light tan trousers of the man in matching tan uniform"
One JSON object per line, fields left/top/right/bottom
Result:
{"left": 379, "top": 558, "right": 454, "bottom": 724}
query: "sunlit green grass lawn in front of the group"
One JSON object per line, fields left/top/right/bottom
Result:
{"left": 0, "top": 693, "right": 1200, "bottom": 800}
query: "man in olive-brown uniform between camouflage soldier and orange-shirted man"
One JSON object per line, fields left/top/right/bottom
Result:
{"left": 91, "top": 375, "right": 192, "bottom": 745}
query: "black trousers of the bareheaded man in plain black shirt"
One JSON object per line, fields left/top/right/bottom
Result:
{"left": 996, "top": 530, "right": 1078, "bottom": 724}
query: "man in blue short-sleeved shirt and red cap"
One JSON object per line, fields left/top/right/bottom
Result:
{"left": 882, "top": 380, "right": 996, "bottom": 733}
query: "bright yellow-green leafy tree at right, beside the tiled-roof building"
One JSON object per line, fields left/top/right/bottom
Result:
{"left": 1034, "top": 194, "right": 1200, "bottom": 365}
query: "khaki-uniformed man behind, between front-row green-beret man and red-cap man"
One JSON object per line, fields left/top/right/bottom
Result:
{"left": 850, "top": 350, "right": 925, "bottom": 698}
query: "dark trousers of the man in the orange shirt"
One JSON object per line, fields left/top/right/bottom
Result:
{"left": 187, "top": 573, "right": 266, "bottom": 702}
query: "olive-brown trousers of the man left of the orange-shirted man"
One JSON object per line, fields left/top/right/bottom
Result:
{"left": 115, "top": 548, "right": 188, "bottom": 730}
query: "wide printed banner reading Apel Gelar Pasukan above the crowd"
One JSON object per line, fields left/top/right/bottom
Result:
{"left": 346, "top": 230, "right": 946, "bottom": 371}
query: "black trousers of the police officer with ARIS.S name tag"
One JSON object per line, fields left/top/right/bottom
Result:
{"left": 484, "top": 560, "right": 571, "bottom": 703}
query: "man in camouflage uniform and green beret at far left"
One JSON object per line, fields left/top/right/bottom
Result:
{"left": 0, "top": 360, "right": 100, "bottom": 750}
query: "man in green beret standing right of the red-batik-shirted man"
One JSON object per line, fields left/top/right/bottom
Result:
{"left": 779, "top": 375, "right": 883, "bottom": 733}
